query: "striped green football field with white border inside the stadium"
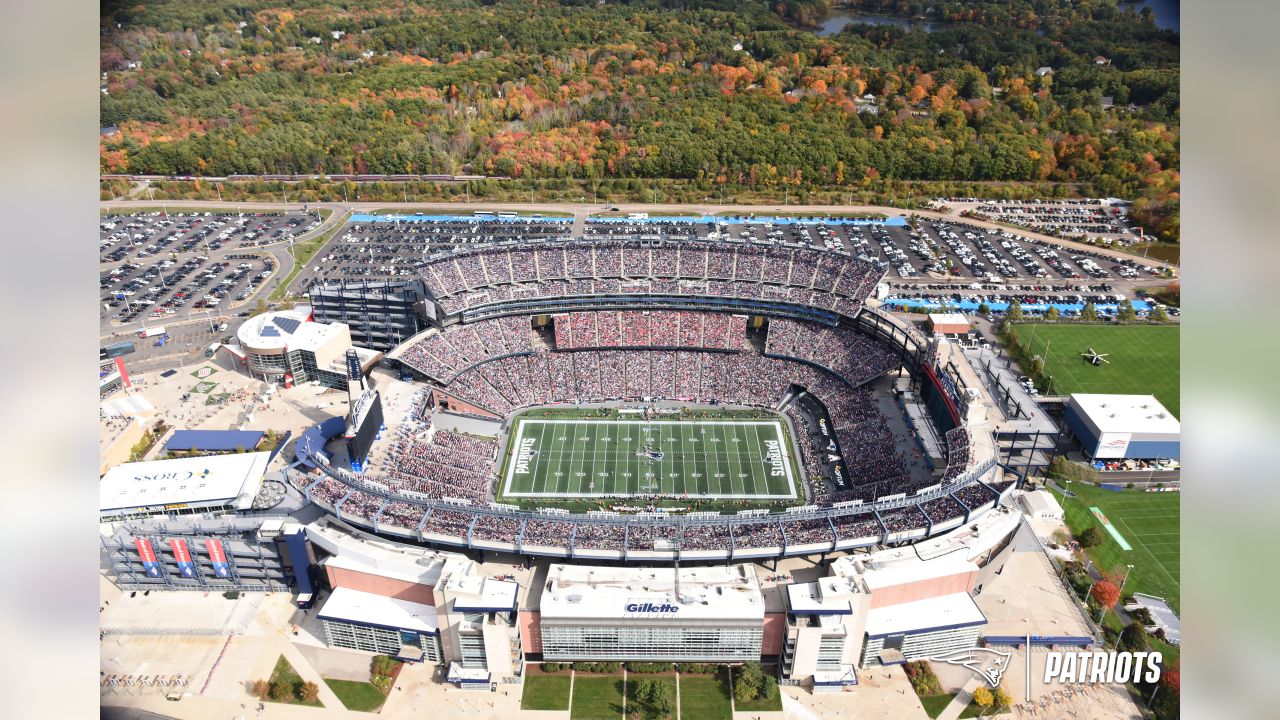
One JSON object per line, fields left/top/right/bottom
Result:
{"left": 499, "top": 418, "right": 799, "bottom": 500}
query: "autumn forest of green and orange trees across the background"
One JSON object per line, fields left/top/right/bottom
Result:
{"left": 100, "top": 0, "right": 1179, "bottom": 240}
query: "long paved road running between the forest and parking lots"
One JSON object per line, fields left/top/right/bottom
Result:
{"left": 101, "top": 200, "right": 1164, "bottom": 266}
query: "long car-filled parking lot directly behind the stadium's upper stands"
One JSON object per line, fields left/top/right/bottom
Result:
{"left": 277, "top": 207, "right": 1164, "bottom": 304}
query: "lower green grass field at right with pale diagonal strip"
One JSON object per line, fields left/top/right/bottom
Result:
{"left": 1059, "top": 483, "right": 1181, "bottom": 611}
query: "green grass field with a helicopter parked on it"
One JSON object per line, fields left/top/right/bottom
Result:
{"left": 1014, "top": 324, "right": 1180, "bottom": 416}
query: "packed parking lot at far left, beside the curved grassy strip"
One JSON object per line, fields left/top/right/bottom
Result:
{"left": 99, "top": 213, "right": 320, "bottom": 328}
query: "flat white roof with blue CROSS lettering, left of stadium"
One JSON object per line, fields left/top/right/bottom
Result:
{"left": 99, "top": 452, "right": 271, "bottom": 515}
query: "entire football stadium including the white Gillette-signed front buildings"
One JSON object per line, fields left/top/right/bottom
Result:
{"left": 102, "top": 217, "right": 1070, "bottom": 692}
